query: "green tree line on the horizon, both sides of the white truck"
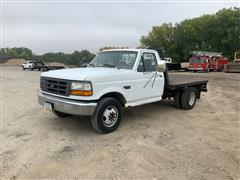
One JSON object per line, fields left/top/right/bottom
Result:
{"left": 0, "top": 7, "right": 240, "bottom": 66}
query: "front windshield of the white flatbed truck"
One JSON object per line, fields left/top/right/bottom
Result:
{"left": 90, "top": 51, "right": 138, "bottom": 69}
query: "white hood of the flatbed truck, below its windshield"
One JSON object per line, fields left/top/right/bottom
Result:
{"left": 41, "top": 67, "right": 123, "bottom": 81}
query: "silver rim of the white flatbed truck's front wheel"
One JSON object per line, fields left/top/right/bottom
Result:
{"left": 102, "top": 105, "right": 118, "bottom": 127}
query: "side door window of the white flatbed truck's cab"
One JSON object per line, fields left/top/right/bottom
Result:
{"left": 137, "top": 53, "right": 157, "bottom": 72}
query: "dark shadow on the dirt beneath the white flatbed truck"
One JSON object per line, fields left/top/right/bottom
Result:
{"left": 48, "top": 100, "right": 178, "bottom": 135}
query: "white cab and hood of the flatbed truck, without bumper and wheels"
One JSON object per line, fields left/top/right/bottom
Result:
{"left": 41, "top": 49, "right": 165, "bottom": 107}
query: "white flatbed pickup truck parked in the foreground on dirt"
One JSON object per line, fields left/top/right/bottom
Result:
{"left": 38, "top": 49, "right": 208, "bottom": 133}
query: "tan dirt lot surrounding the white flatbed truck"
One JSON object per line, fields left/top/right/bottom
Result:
{"left": 1, "top": 67, "right": 240, "bottom": 180}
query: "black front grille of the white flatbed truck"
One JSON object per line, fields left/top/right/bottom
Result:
{"left": 40, "top": 77, "right": 70, "bottom": 96}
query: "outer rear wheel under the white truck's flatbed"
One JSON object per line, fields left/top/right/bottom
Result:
{"left": 181, "top": 87, "right": 197, "bottom": 110}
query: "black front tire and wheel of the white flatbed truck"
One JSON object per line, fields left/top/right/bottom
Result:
{"left": 91, "top": 97, "right": 122, "bottom": 133}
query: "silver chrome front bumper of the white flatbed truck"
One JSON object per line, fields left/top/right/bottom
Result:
{"left": 38, "top": 93, "right": 97, "bottom": 116}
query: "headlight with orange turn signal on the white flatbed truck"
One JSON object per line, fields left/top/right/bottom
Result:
{"left": 70, "top": 82, "right": 93, "bottom": 96}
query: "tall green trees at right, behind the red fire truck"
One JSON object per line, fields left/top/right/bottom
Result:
{"left": 140, "top": 7, "right": 240, "bottom": 62}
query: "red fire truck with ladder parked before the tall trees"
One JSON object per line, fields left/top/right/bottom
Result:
{"left": 188, "top": 51, "right": 228, "bottom": 72}
